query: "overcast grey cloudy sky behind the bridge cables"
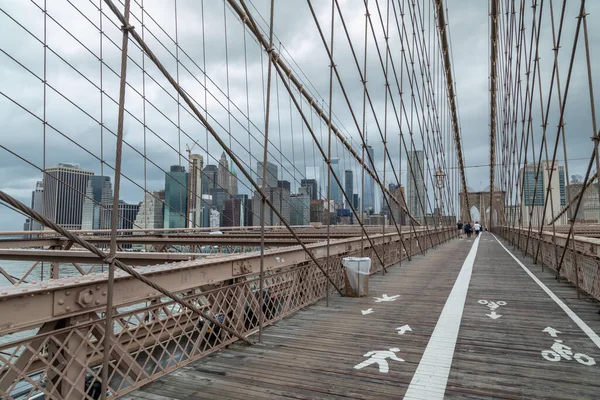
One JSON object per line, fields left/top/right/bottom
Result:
{"left": 0, "top": 0, "right": 600, "bottom": 230}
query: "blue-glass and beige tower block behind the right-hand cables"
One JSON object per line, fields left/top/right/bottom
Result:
{"left": 519, "top": 161, "right": 567, "bottom": 226}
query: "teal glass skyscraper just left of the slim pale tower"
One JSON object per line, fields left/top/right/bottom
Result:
{"left": 164, "top": 165, "right": 188, "bottom": 229}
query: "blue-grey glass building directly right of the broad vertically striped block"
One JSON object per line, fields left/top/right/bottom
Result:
{"left": 81, "top": 176, "right": 113, "bottom": 230}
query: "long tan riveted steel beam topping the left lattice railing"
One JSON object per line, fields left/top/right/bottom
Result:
{"left": 0, "top": 228, "right": 454, "bottom": 335}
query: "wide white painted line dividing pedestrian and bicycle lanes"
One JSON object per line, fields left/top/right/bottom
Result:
{"left": 404, "top": 236, "right": 480, "bottom": 400}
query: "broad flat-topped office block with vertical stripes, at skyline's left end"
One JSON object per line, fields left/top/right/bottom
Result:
{"left": 42, "top": 163, "right": 94, "bottom": 230}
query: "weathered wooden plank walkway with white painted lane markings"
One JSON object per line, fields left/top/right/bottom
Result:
{"left": 124, "top": 233, "right": 600, "bottom": 400}
